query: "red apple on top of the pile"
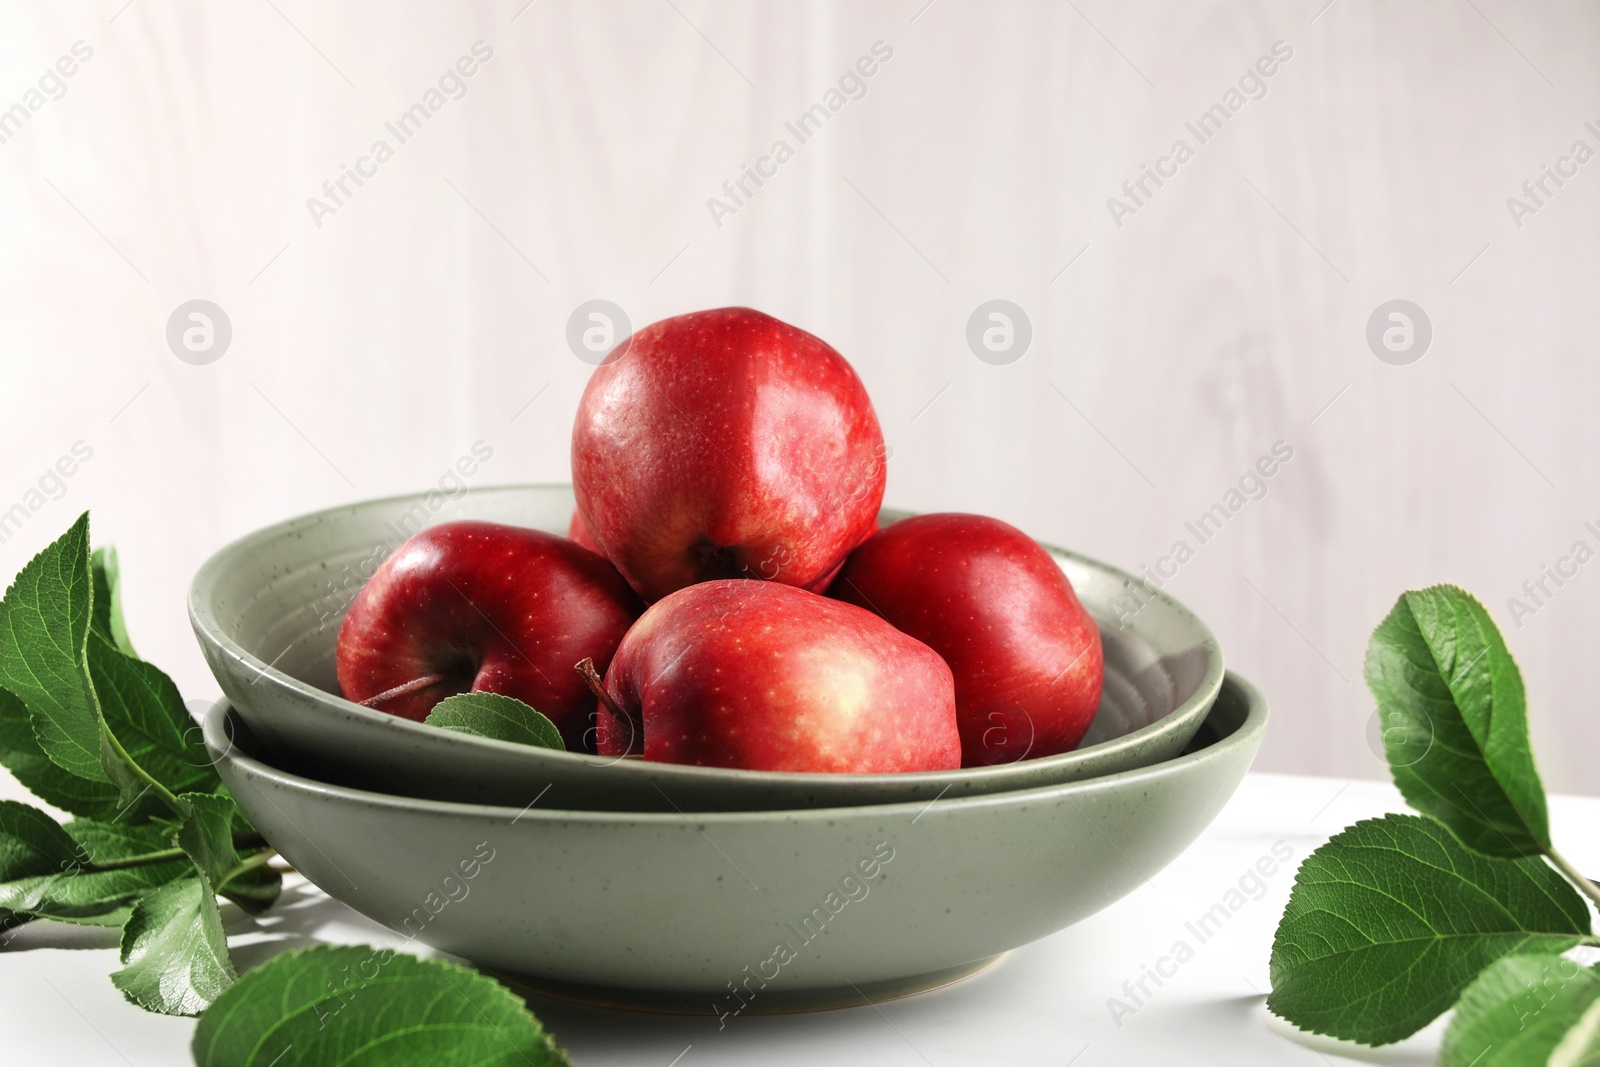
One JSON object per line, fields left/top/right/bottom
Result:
{"left": 573, "top": 307, "right": 885, "bottom": 601}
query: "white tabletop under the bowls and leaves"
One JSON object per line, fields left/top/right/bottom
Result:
{"left": 0, "top": 774, "right": 1600, "bottom": 1067}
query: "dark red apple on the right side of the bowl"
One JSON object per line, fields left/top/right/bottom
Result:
{"left": 829, "top": 514, "right": 1104, "bottom": 766}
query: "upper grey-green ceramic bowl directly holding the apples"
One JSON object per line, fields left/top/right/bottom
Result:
{"left": 189, "top": 486, "right": 1224, "bottom": 813}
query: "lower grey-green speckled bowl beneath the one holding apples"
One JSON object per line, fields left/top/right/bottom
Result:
{"left": 205, "top": 675, "right": 1267, "bottom": 1014}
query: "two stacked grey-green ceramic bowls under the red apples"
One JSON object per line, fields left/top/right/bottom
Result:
{"left": 190, "top": 486, "right": 1267, "bottom": 1013}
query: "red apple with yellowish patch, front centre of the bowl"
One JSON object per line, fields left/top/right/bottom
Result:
{"left": 595, "top": 579, "right": 962, "bottom": 773}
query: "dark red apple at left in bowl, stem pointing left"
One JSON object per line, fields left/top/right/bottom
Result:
{"left": 336, "top": 522, "right": 645, "bottom": 750}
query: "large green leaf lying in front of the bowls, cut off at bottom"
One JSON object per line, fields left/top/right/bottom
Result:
{"left": 192, "top": 945, "right": 570, "bottom": 1067}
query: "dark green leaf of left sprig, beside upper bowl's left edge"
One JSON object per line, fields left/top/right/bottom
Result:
{"left": 88, "top": 633, "right": 221, "bottom": 793}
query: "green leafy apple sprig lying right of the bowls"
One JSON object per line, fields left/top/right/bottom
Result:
{"left": 1267, "top": 585, "right": 1600, "bottom": 1067}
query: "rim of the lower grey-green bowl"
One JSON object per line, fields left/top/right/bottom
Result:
{"left": 202, "top": 670, "right": 1267, "bottom": 827}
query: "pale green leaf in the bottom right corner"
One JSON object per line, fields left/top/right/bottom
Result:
{"left": 1438, "top": 953, "right": 1600, "bottom": 1067}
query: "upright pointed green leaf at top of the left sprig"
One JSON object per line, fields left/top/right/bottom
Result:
{"left": 0, "top": 512, "right": 110, "bottom": 782}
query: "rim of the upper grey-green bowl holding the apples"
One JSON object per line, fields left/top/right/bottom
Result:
{"left": 189, "top": 482, "right": 1227, "bottom": 789}
